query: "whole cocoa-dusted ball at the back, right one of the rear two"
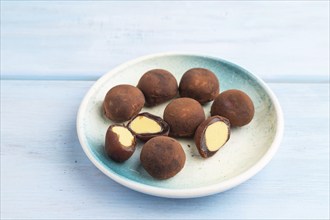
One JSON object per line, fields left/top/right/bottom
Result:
{"left": 179, "top": 68, "right": 220, "bottom": 104}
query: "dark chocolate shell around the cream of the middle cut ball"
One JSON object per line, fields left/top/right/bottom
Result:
{"left": 127, "top": 112, "right": 170, "bottom": 142}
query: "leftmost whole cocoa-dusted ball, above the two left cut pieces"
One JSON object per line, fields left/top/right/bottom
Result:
{"left": 103, "top": 85, "right": 145, "bottom": 122}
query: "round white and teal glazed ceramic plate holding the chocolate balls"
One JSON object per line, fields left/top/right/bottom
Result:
{"left": 77, "top": 53, "right": 284, "bottom": 198}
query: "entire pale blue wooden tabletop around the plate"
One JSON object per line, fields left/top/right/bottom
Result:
{"left": 0, "top": 1, "right": 329, "bottom": 219}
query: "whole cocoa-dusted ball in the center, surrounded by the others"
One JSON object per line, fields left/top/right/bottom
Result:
{"left": 163, "top": 98, "right": 205, "bottom": 137}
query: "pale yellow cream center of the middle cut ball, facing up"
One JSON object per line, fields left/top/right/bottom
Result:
{"left": 130, "top": 116, "right": 162, "bottom": 134}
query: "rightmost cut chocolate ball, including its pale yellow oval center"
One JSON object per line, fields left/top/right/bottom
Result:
{"left": 194, "top": 116, "right": 230, "bottom": 158}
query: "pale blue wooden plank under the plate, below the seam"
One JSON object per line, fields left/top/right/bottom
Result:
{"left": 0, "top": 80, "right": 329, "bottom": 219}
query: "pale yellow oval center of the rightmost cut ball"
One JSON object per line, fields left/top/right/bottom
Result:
{"left": 205, "top": 121, "right": 228, "bottom": 151}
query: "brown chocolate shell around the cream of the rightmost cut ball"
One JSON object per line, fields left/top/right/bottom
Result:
{"left": 194, "top": 115, "right": 230, "bottom": 158}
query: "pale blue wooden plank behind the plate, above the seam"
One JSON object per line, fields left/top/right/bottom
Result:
{"left": 1, "top": 1, "right": 329, "bottom": 82}
